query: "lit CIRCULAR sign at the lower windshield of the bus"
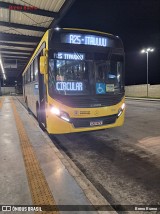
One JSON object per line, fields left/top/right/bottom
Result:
{"left": 56, "top": 82, "right": 83, "bottom": 91}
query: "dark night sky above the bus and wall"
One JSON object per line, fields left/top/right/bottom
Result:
{"left": 59, "top": 0, "right": 160, "bottom": 85}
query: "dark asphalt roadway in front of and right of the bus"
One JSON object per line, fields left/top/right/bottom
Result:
{"left": 53, "top": 100, "right": 160, "bottom": 210}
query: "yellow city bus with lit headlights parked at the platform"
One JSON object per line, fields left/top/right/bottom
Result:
{"left": 22, "top": 28, "right": 125, "bottom": 134}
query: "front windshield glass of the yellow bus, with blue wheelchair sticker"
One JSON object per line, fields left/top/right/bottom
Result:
{"left": 48, "top": 52, "right": 124, "bottom": 96}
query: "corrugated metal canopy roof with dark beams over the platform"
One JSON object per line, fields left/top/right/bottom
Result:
{"left": 0, "top": 0, "right": 75, "bottom": 78}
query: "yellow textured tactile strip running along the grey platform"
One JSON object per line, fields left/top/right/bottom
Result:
{"left": 11, "top": 99, "right": 59, "bottom": 214}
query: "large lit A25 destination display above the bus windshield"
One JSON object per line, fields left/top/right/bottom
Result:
{"left": 62, "top": 34, "right": 108, "bottom": 47}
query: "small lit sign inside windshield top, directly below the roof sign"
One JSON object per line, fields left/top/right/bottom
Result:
{"left": 54, "top": 52, "right": 85, "bottom": 60}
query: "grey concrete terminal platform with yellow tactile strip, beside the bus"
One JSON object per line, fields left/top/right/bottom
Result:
{"left": 0, "top": 97, "right": 113, "bottom": 214}
